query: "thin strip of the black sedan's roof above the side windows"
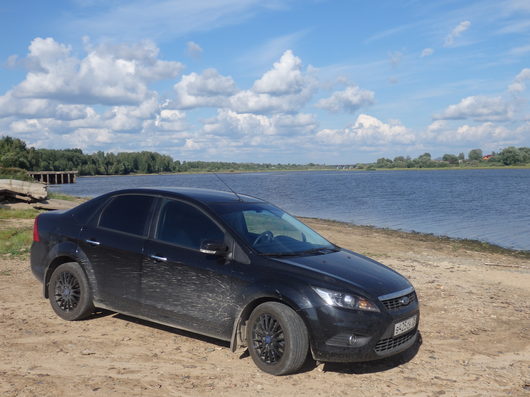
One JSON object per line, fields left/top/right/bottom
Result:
{"left": 110, "top": 187, "right": 265, "bottom": 204}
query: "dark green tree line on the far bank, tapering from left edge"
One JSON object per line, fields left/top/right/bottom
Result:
{"left": 0, "top": 136, "right": 331, "bottom": 175}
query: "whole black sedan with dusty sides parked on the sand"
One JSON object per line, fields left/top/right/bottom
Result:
{"left": 31, "top": 188, "right": 419, "bottom": 375}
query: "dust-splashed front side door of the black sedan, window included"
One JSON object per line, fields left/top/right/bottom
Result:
{"left": 141, "top": 199, "right": 241, "bottom": 339}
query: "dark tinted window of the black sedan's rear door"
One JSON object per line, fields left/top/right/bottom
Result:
{"left": 99, "top": 194, "right": 154, "bottom": 236}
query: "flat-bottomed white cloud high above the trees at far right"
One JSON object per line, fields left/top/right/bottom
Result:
{"left": 433, "top": 96, "right": 514, "bottom": 121}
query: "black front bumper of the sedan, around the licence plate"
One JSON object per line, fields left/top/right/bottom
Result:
{"left": 300, "top": 301, "right": 420, "bottom": 362}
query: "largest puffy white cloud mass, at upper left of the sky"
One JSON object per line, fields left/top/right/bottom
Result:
{"left": 12, "top": 38, "right": 182, "bottom": 105}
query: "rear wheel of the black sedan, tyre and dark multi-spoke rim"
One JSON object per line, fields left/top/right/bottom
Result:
{"left": 48, "top": 262, "right": 94, "bottom": 321}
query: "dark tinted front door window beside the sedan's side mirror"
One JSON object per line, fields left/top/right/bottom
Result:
{"left": 157, "top": 201, "right": 224, "bottom": 249}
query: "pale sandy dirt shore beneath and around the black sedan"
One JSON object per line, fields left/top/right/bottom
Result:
{"left": 0, "top": 220, "right": 530, "bottom": 397}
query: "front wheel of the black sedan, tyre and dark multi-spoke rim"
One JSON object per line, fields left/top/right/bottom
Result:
{"left": 246, "top": 302, "right": 309, "bottom": 375}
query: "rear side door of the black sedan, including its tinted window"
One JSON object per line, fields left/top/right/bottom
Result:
{"left": 79, "top": 194, "right": 155, "bottom": 314}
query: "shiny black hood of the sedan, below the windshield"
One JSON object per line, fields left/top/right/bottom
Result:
{"left": 278, "top": 249, "right": 411, "bottom": 297}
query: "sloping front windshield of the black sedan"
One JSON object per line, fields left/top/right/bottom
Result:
{"left": 209, "top": 203, "right": 337, "bottom": 256}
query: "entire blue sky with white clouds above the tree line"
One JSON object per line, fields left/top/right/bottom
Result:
{"left": 0, "top": 0, "right": 530, "bottom": 164}
